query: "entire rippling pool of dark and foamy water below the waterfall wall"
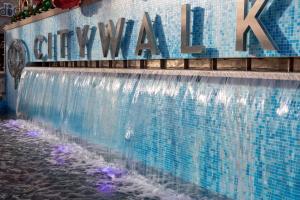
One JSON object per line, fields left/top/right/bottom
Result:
{"left": 0, "top": 120, "right": 225, "bottom": 200}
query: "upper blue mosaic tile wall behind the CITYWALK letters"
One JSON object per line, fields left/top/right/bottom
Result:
{"left": 7, "top": 0, "right": 300, "bottom": 61}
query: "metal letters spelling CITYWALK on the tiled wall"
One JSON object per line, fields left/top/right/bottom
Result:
{"left": 34, "top": 0, "right": 277, "bottom": 60}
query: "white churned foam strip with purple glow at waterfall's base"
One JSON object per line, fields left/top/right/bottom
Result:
{"left": 0, "top": 120, "right": 198, "bottom": 200}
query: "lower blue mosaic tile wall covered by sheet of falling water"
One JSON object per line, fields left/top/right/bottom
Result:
{"left": 18, "top": 71, "right": 300, "bottom": 200}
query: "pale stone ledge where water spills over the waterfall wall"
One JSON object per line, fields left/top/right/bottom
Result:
{"left": 25, "top": 67, "right": 300, "bottom": 81}
